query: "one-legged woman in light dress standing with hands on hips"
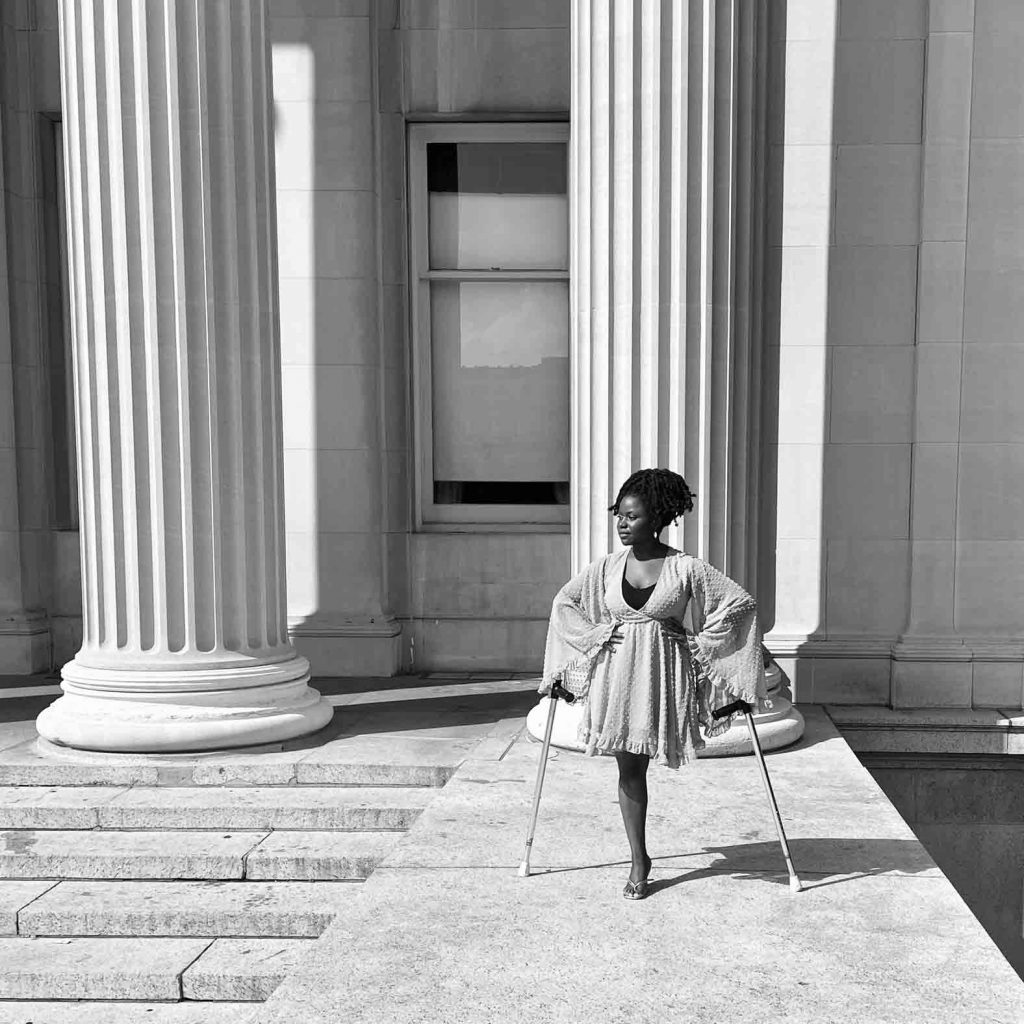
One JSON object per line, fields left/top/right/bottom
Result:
{"left": 541, "top": 469, "right": 765, "bottom": 899}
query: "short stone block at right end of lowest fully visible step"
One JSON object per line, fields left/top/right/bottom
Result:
{"left": 181, "top": 939, "right": 315, "bottom": 995}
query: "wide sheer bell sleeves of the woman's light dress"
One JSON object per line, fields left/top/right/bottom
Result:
{"left": 539, "top": 551, "right": 770, "bottom": 736}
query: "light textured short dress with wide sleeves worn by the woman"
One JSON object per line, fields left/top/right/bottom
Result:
{"left": 541, "top": 549, "right": 765, "bottom": 768}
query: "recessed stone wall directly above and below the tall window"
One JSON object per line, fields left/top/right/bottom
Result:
{"left": 397, "top": 0, "right": 569, "bottom": 670}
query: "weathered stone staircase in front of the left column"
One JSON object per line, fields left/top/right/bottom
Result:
{"left": 0, "top": 752, "right": 453, "bottom": 1024}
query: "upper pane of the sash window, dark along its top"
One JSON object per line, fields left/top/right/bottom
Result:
{"left": 427, "top": 142, "right": 568, "bottom": 270}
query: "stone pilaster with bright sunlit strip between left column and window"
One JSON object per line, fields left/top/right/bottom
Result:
{"left": 269, "top": 0, "right": 409, "bottom": 675}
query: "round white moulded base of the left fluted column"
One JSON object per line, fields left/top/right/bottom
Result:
{"left": 36, "top": 656, "right": 334, "bottom": 754}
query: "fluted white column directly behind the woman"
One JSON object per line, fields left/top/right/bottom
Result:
{"left": 530, "top": 0, "right": 802, "bottom": 750}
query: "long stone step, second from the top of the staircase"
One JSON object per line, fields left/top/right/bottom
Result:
{"left": 0, "top": 785, "right": 436, "bottom": 831}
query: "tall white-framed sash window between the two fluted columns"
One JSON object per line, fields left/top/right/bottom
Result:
{"left": 410, "top": 124, "right": 569, "bottom": 523}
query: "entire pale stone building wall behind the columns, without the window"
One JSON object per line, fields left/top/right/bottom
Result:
{"left": 12, "top": 0, "right": 1024, "bottom": 688}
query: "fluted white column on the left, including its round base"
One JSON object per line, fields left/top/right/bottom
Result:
{"left": 38, "top": 0, "right": 331, "bottom": 752}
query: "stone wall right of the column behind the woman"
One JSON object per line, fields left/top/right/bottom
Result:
{"left": 762, "top": 0, "right": 1024, "bottom": 708}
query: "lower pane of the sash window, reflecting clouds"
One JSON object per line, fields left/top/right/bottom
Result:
{"left": 430, "top": 282, "right": 569, "bottom": 504}
